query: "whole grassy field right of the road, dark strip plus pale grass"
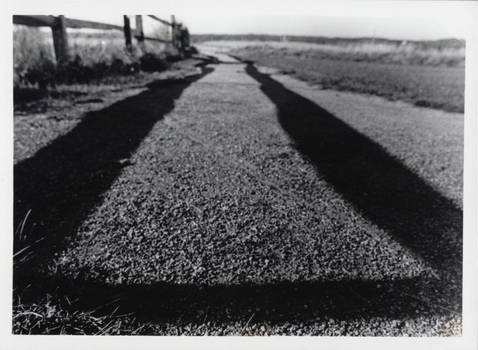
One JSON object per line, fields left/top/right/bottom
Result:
{"left": 206, "top": 41, "right": 465, "bottom": 112}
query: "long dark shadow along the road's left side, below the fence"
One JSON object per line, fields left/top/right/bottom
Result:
{"left": 14, "top": 67, "right": 212, "bottom": 280}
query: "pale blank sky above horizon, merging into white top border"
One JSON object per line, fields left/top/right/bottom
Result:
{"left": 11, "top": 0, "right": 471, "bottom": 40}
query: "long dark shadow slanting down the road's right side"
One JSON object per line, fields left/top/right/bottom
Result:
{"left": 246, "top": 62, "right": 462, "bottom": 283}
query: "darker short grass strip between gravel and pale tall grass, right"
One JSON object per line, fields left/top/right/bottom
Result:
{"left": 233, "top": 47, "right": 465, "bottom": 112}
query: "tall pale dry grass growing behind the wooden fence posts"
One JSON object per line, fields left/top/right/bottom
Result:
{"left": 13, "top": 25, "right": 176, "bottom": 88}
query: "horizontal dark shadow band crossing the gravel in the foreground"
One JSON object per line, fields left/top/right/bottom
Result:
{"left": 15, "top": 276, "right": 452, "bottom": 332}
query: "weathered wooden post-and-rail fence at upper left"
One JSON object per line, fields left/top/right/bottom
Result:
{"left": 13, "top": 15, "right": 190, "bottom": 65}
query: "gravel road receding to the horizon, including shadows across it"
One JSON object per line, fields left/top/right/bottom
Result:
{"left": 16, "top": 47, "right": 463, "bottom": 335}
